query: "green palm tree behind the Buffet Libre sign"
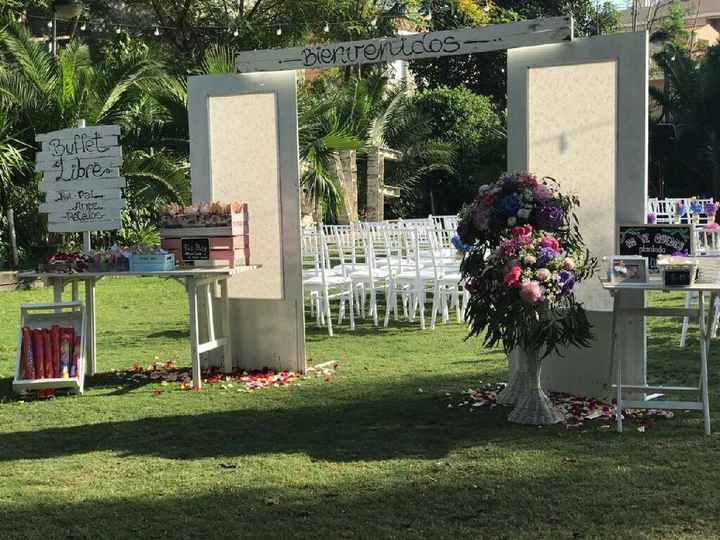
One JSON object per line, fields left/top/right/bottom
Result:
{"left": 0, "top": 19, "right": 189, "bottom": 248}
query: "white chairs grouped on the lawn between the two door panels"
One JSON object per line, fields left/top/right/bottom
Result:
{"left": 303, "top": 216, "right": 468, "bottom": 335}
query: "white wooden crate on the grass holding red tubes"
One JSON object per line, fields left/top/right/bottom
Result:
{"left": 13, "top": 302, "right": 85, "bottom": 394}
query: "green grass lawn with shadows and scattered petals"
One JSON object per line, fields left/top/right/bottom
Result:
{"left": 0, "top": 279, "right": 720, "bottom": 539}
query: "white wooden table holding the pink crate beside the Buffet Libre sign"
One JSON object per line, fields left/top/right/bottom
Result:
{"left": 18, "top": 266, "right": 258, "bottom": 388}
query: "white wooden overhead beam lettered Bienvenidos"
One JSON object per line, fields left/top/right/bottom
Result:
{"left": 235, "top": 17, "right": 573, "bottom": 73}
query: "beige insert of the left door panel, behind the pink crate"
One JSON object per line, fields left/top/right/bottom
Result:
{"left": 208, "top": 93, "right": 283, "bottom": 299}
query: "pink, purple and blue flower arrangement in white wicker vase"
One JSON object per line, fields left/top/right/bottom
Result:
{"left": 458, "top": 173, "right": 597, "bottom": 424}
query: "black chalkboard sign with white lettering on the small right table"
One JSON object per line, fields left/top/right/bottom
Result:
{"left": 619, "top": 225, "right": 695, "bottom": 272}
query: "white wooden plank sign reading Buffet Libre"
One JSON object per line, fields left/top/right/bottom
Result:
{"left": 35, "top": 126, "right": 125, "bottom": 232}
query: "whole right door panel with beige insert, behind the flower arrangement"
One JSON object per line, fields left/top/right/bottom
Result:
{"left": 508, "top": 33, "right": 648, "bottom": 396}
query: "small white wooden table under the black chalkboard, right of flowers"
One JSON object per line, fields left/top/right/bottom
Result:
{"left": 603, "top": 277, "right": 720, "bottom": 435}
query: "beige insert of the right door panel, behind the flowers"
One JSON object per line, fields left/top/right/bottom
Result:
{"left": 528, "top": 61, "right": 616, "bottom": 311}
